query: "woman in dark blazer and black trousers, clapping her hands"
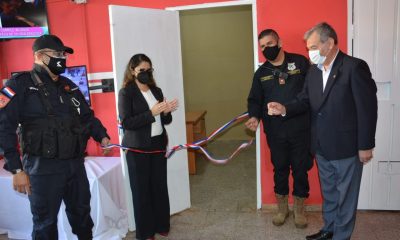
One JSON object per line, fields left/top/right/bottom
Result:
{"left": 118, "top": 54, "right": 178, "bottom": 239}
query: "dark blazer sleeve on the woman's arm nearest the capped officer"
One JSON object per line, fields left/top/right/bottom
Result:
{"left": 118, "top": 86, "right": 156, "bottom": 130}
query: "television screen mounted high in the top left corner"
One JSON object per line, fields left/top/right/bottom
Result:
{"left": 0, "top": 0, "right": 49, "bottom": 39}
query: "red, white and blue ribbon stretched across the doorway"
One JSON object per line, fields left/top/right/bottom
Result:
{"left": 102, "top": 112, "right": 253, "bottom": 164}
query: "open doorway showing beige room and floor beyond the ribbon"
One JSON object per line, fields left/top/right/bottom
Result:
{"left": 179, "top": 5, "right": 257, "bottom": 211}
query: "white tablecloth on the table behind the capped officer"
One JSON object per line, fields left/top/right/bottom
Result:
{"left": 0, "top": 157, "right": 128, "bottom": 240}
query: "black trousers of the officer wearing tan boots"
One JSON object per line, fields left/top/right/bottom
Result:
{"left": 267, "top": 131, "right": 313, "bottom": 198}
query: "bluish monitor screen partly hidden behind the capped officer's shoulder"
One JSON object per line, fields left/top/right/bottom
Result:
{"left": 60, "top": 66, "right": 90, "bottom": 105}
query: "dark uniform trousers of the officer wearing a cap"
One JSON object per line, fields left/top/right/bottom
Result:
{"left": 29, "top": 160, "right": 93, "bottom": 240}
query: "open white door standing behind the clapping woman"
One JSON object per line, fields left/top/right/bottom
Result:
{"left": 109, "top": 5, "right": 190, "bottom": 230}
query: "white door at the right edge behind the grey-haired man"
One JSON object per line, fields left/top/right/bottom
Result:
{"left": 348, "top": 0, "right": 400, "bottom": 210}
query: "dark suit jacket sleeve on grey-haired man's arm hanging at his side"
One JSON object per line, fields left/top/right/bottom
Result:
{"left": 351, "top": 60, "right": 378, "bottom": 150}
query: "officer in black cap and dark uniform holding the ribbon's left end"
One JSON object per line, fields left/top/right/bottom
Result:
{"left": 0, "top": 35, "right": 109, "bottom": 240}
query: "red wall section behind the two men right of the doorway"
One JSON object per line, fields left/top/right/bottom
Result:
{"left": 257, "top": 0, "right": 347, "bottom": 204}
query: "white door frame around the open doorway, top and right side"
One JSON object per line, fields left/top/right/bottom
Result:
{"left": 165, "top": 0, "right": 262, "bottom": 209}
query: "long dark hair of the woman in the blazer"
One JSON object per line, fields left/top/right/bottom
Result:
{"left": 122, "top": 53, "right": 157, "bottom": 88}
